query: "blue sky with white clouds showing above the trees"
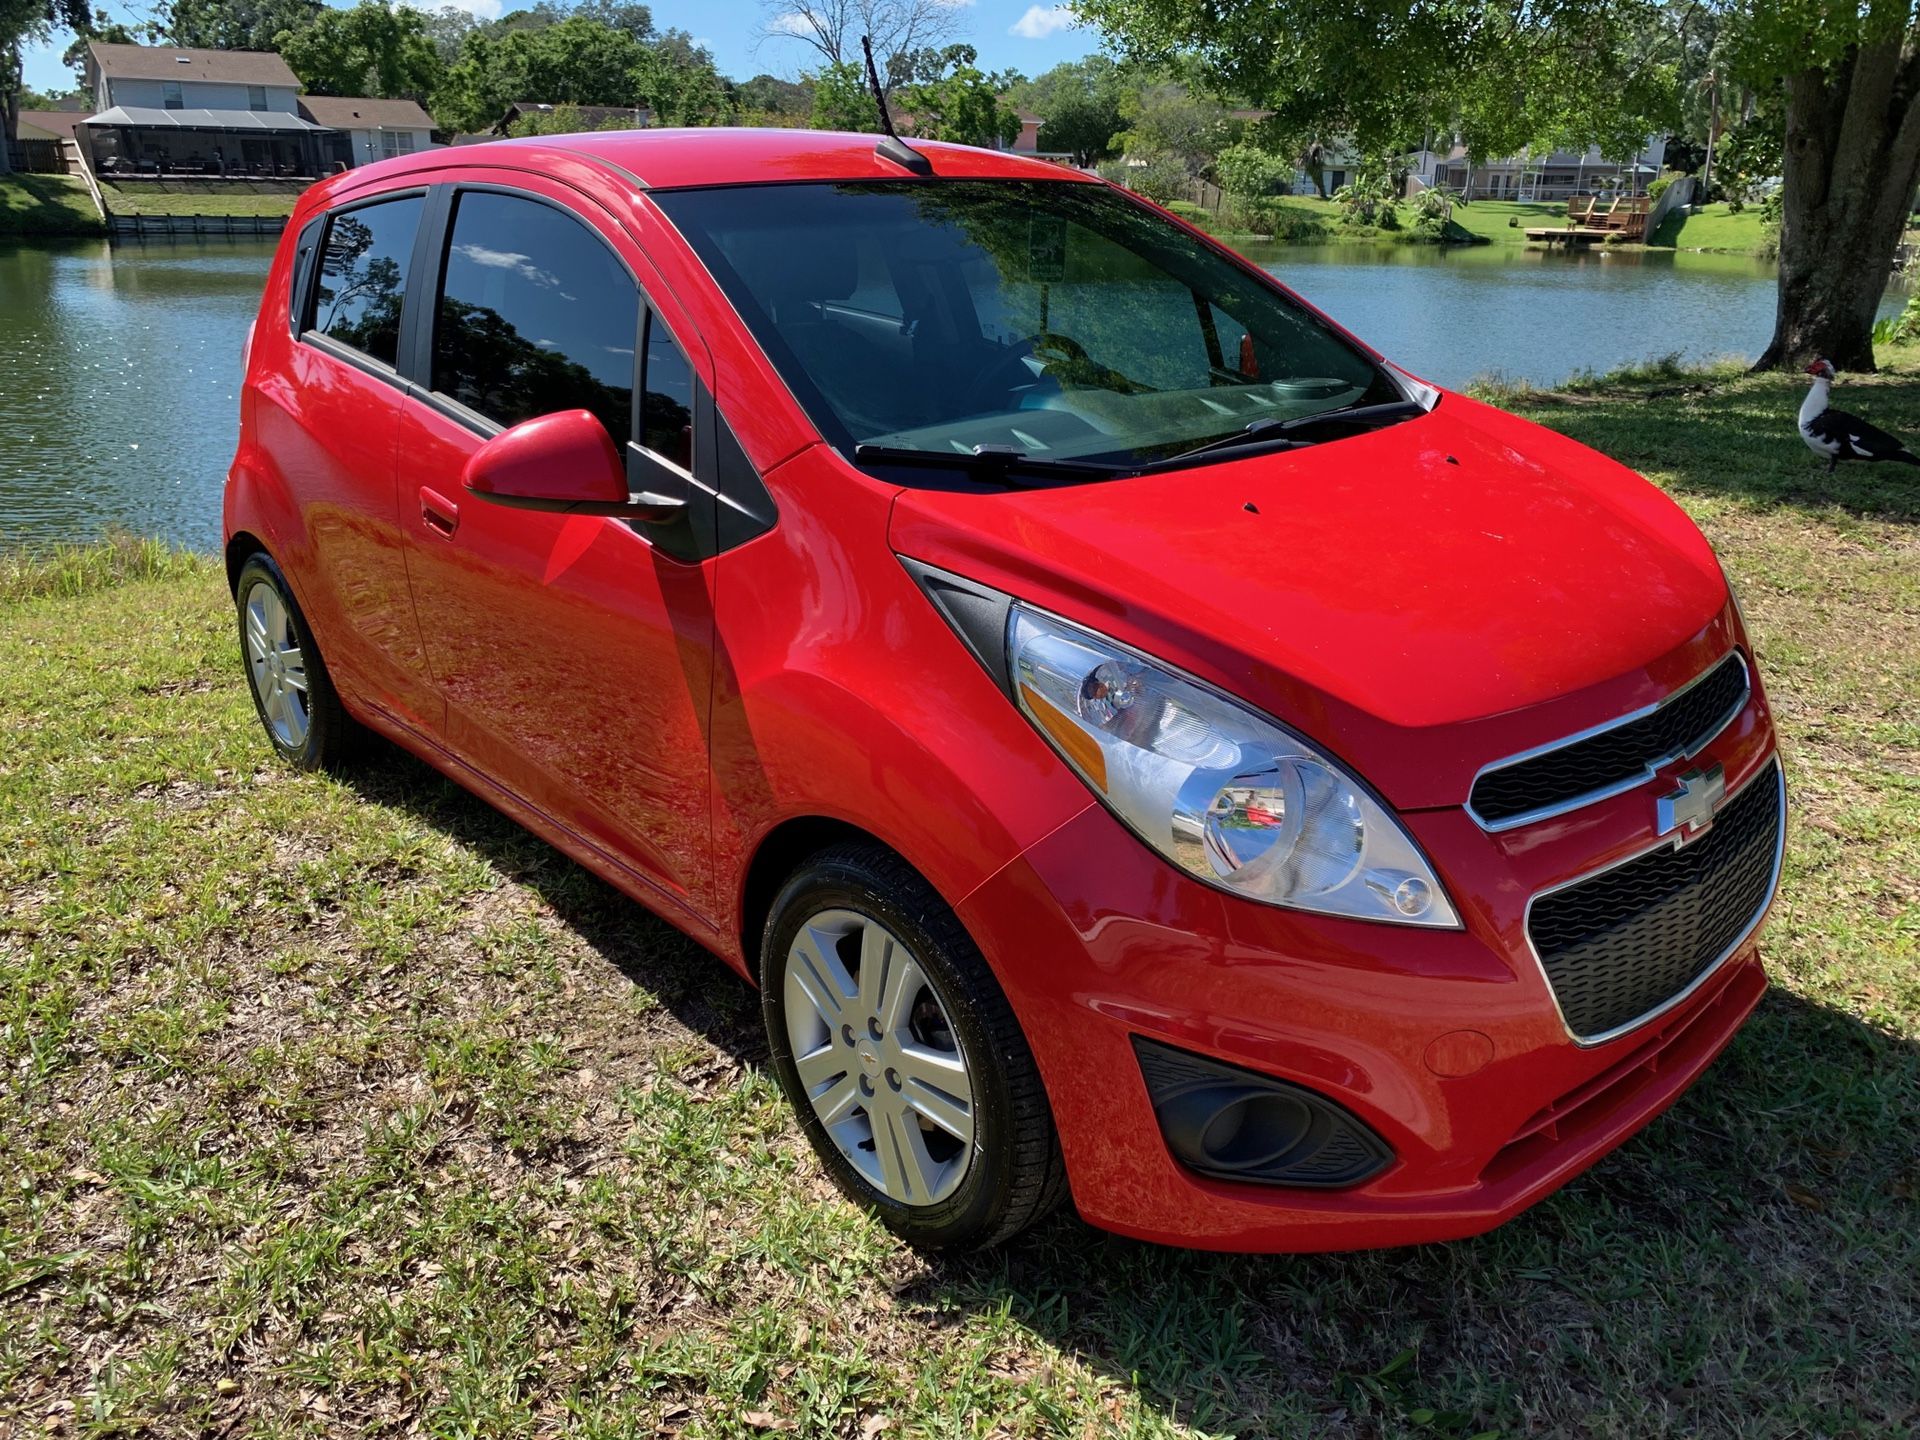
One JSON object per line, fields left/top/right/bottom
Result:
{"left": 25, "top": 0, "right": 1098, "bottom": 90}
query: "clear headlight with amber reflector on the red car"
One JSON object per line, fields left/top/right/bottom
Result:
{"left": 1008, "top": 605, "right": 1459, "bottom": 927}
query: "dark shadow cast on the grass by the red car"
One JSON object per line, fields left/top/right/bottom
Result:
{"left": 337, "top": 751, "right": 1920, "bottom": 1438}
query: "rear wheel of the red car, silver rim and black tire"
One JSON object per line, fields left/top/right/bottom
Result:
{"left": 234, "top": 553, "right": 359, "bottom": 770}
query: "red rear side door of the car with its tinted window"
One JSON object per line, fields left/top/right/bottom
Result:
{"left": 253, "top": 186, "right": 440, "bottom": 733}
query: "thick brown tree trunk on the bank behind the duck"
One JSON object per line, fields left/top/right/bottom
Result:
{"left": 1753, "top": 44, "right": 1920, "bottom": 371}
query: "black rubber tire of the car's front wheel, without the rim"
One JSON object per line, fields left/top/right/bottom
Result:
{"left": 760, "top": 841, "right": 1066, "bottom": 1252}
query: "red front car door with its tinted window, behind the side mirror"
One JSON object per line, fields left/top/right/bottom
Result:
{"left": 399, "top": 180, "right": 712, "bottom": 916}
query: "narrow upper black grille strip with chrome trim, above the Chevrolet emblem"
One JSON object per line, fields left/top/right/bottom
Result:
{"left": 1469, "top": 651, "right": 1747, "bottom": 826}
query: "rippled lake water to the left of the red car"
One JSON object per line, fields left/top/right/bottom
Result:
{"left": 0, "top": 240, "right": 275, "bottom": 549}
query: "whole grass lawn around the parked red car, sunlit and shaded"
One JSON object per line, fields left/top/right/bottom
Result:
{"left": 0, "top": 359, "right": 1920, "bottom": 1440}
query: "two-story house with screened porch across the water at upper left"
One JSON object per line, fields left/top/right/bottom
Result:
{"left": 79, "top": 40, "right": 330, "bottom": 179}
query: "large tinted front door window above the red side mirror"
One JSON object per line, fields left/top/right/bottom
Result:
{"left": 434, "top": 190, "right": 639, "bottom": 445}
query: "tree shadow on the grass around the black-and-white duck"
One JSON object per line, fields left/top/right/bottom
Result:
{"left": 1507, "top": 372, "right": 1920, "bottom": 524}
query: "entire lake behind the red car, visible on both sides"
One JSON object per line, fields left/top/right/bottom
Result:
{"left": 0, "top": 240, "right": 1899, "bottom": 549}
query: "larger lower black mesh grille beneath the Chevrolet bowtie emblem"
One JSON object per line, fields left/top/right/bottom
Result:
{"left": 1526, "top": 770, "right": 1786, "bottom": 1041}
